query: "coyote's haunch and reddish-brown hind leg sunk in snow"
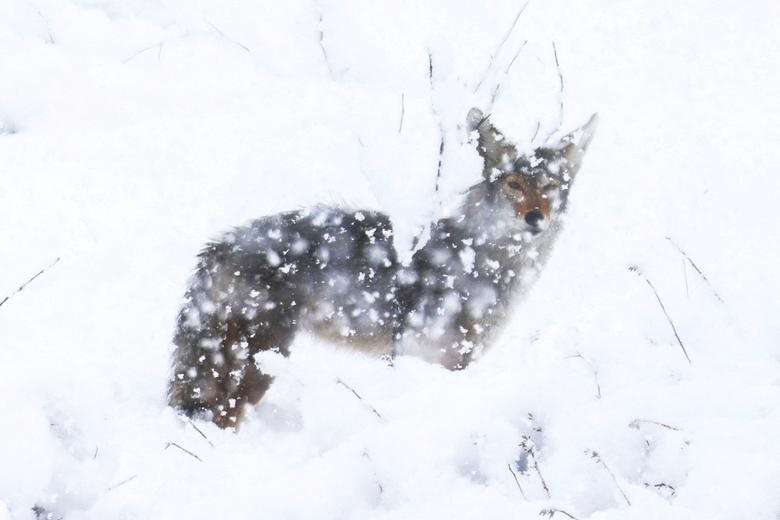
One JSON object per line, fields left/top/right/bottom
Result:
{"left": 169, "top": 244, "right": 298, "bottom": 428}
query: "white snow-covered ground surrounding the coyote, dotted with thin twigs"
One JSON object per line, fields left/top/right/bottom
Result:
{"left": 0, "top": 0, "right": 780, "bottom": 520}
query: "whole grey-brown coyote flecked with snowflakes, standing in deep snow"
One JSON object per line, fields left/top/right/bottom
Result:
{"left": 169, "top": 108, "right": 596, "bottom": 428}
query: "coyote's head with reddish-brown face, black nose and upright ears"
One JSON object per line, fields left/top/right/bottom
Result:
{"left": 468, "top": 108, "right": 598, "bottom": 235}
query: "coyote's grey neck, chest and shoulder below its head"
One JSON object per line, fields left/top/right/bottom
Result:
{"left": 399, "top": 182, "right": 558, "bottom": 368}
